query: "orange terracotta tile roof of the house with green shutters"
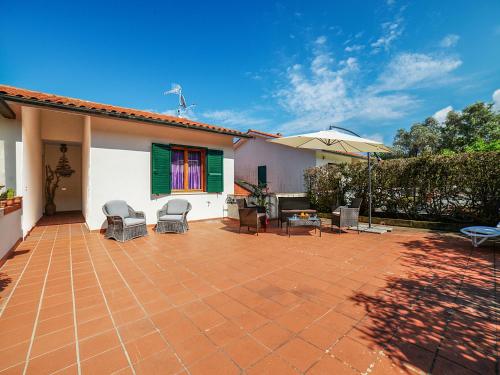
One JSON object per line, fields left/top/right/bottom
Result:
{"left": 0, "top": 85, "right": 246, "bottom": 137}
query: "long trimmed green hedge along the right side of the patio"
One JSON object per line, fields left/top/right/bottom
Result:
{"left": 305, "top": 152, "right": 500, "bottom": 224}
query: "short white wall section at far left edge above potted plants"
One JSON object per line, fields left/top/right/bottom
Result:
{"left": 0, "top": 116, "right": 22, "bottom": 191}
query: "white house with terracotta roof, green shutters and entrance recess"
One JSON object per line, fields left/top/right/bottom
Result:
{"left": 0, "top": 85, "right": 247, "bottom": 235}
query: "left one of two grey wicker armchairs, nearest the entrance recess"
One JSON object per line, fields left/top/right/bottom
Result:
{"left": 102, "top": 200, "right": 148, "bottom": 242}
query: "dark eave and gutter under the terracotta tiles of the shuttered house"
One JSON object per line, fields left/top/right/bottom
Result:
{"left": 0, "top": 93, "right": 251, "bottom": 138}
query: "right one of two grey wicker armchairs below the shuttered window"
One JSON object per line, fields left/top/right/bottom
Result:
{"left": 156, "top": 199, "right": 192, "bottom": 233}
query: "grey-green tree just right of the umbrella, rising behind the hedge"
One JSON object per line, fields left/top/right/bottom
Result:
{"left": 394, "top": 117, "right": 441, "bottom": 157}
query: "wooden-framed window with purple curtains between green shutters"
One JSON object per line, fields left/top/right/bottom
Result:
{"left": 172, "top": 147, "right": 205, "bottom": 191}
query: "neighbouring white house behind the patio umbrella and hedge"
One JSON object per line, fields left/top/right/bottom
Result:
{"left": 234, "top": 129, "right": 365, "bottom": 194}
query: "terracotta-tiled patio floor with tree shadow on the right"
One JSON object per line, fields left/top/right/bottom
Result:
{"left": 0, "top": 221, "right": 498, "bottom": 374}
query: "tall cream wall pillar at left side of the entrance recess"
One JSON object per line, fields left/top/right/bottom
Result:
{"left": 21, "top": 106, "right": 43, "bottom": 235}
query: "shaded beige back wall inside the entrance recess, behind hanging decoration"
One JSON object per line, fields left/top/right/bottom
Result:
{"left": 43, "top": 143, "right": 82, "bottom": 212}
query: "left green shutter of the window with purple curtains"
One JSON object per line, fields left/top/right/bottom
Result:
{"left": 151, "top": 143, "right": 172, "bottom": 195}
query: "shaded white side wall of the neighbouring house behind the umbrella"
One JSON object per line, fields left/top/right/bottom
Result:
{"left": 234, "top": 137, "right": 316, "bottom": 193}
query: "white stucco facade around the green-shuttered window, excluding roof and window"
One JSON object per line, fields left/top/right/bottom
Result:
{"left": 0, "top": 87, "right": 241, "bottom": 235}
